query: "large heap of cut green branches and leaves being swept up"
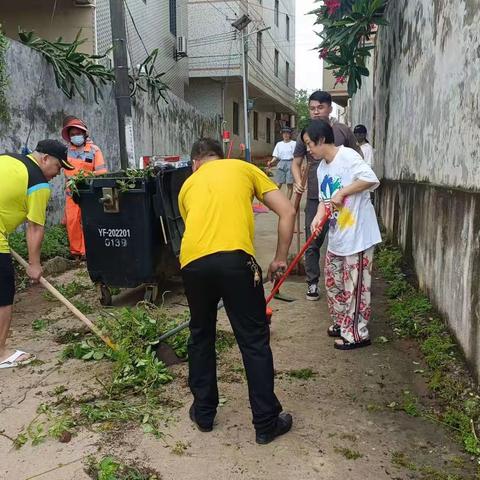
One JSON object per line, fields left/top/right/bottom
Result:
{"left": 13, "top": 304, "right": 188, "bottom": 448}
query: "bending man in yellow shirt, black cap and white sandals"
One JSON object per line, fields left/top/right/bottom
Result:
{"left": 0, "top": 140, "right": 73, "bottom": 369}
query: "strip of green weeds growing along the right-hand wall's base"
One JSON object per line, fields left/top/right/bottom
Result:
{"left": 376, "top": 244, "right": 480, "bottom": 458}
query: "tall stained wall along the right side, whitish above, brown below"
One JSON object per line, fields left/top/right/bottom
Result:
{"left": 353, "top": 0, "right": 480, "bottom": 380}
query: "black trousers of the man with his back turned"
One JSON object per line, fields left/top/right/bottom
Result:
{"left": 182, "top": 251, "right": 282, "bottom": 433}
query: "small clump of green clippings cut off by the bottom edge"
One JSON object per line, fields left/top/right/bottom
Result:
{"left": 85, "top": 456, "right": 162, "bottom": 480}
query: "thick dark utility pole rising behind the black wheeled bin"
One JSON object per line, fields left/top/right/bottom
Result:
{"left": 110, "top": 0, "right": 135, "bottom": 170}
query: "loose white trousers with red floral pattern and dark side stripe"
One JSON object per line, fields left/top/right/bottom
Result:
{"left": 325, "top": 247, "right": 374, "bottom": 343}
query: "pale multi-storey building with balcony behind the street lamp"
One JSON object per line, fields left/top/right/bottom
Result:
{"left": 185, "top": 0, "right": 295, "bottom": 157}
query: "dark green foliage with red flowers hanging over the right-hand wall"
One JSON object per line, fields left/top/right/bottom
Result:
{"left": 311, "top": 0, "right": 387, "bottom": 96}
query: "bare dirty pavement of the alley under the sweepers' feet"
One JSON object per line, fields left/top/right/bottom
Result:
{"left": 0, "top": 209, "right": 475, "bottom": 480}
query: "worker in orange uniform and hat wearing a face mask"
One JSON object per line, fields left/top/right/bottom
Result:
{"left": 62, "top": 116, "right": 107, "bottom": 258}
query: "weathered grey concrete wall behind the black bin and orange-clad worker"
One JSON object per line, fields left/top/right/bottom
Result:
{"left": 0, "top": 41, "right": 218, "bottom": 223}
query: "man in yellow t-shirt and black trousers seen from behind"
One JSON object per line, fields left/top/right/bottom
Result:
{"left": 178, "top": 138, "right": 295, "bottom": 444}
